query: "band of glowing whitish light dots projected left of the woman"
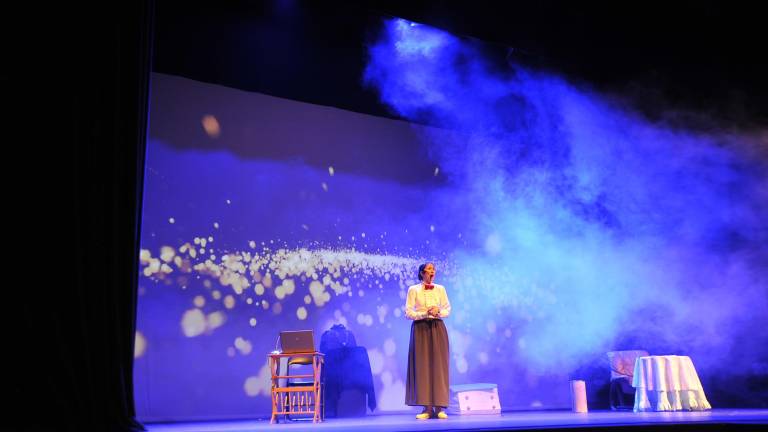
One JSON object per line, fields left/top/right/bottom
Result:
{"left": 140, "top": 241, "right": 426, "bottom": 332}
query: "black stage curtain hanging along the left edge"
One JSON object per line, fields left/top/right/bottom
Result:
{"left": 8, "top": 0, "right": 154, "bottom": 431}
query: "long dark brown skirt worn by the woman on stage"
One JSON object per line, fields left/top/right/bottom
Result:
{"left": 405, "top": 319, "right": 450, "bottom": 408}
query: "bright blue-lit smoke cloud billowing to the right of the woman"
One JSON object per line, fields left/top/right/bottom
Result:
{"left": 365, "top": 19, "right": 768, "bottom": 371}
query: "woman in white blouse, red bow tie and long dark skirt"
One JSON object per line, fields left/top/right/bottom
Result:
{"left": 405, "top": 263, "right": 451, "bottom": 420}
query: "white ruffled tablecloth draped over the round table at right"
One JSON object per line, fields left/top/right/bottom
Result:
{"left": 632, "top": 355, "right": 712, "bottom": 412}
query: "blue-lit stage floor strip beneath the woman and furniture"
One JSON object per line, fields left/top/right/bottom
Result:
{"left": 145, "top": 409, "right": 768, "bottom": 432}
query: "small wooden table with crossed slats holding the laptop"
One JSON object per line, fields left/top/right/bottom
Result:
{"left": 268, "top": 352, "right": 323, "bottom": 423}
